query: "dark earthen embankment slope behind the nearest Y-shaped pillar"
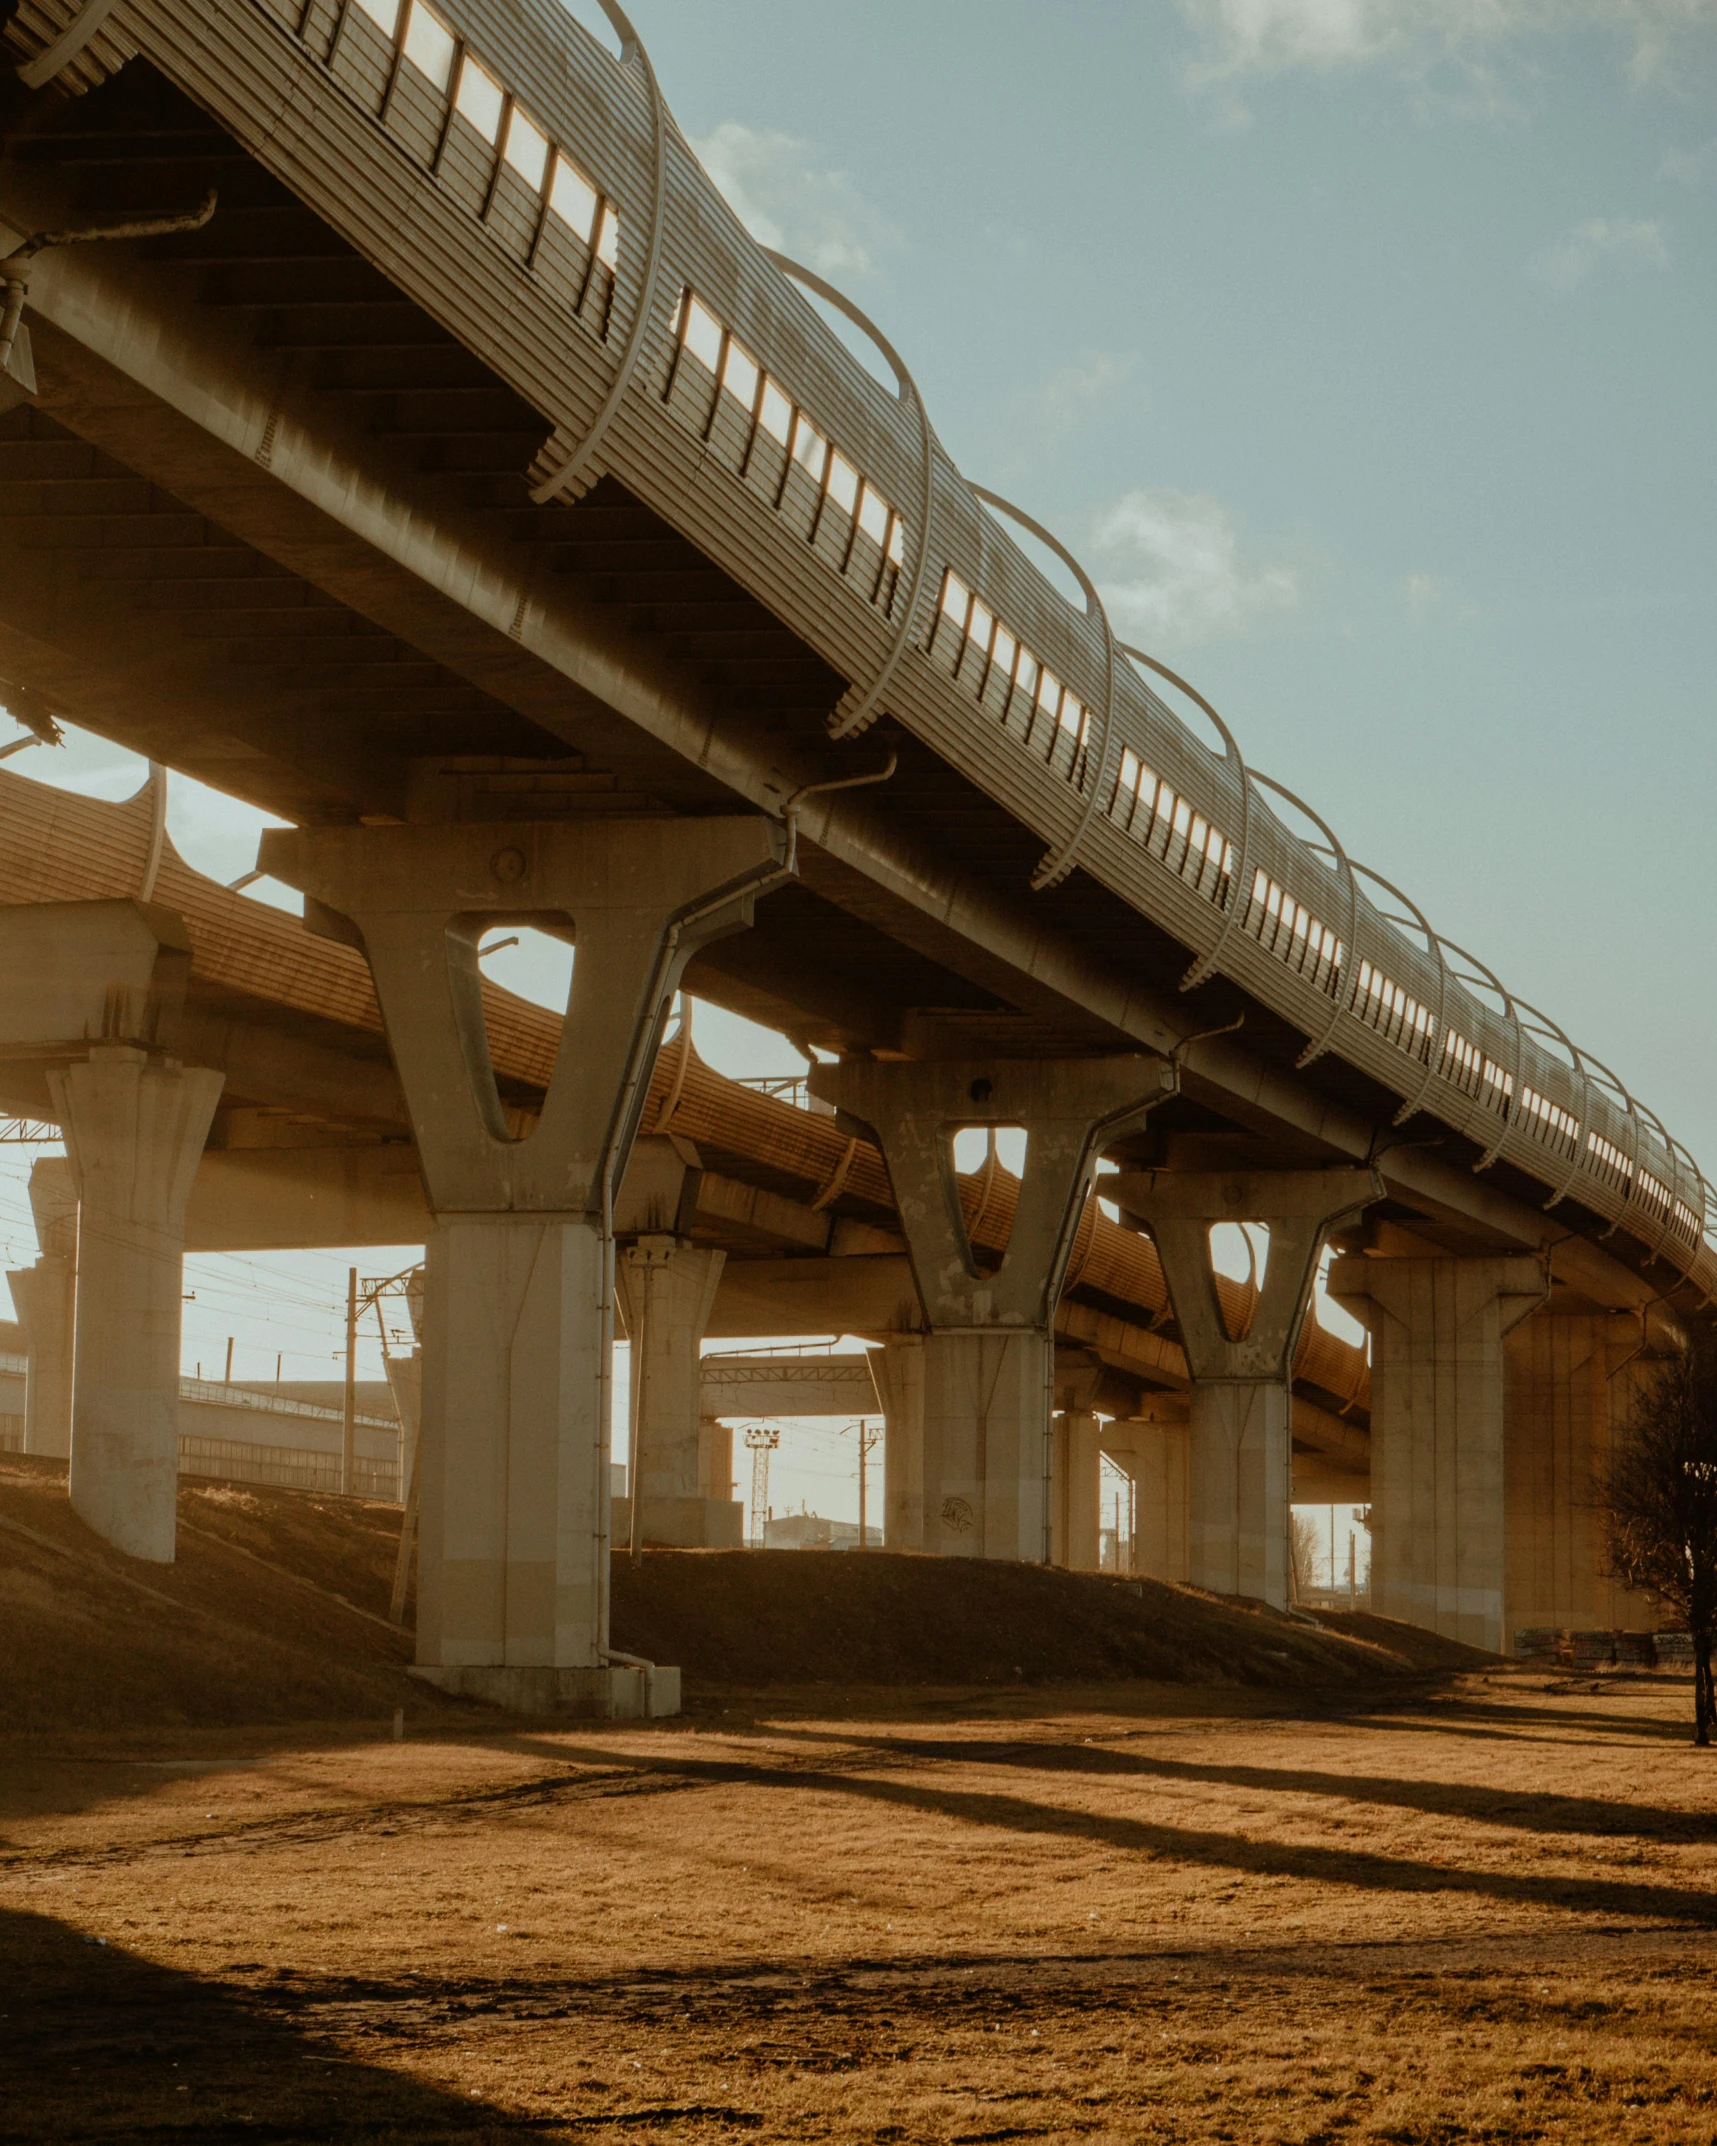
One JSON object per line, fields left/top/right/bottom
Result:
{"left": 0, "top": 1453, "right": 1487, "bottom": 1730}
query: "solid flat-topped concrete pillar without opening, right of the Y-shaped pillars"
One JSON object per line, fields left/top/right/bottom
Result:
{"left": 1329, "top": 1255, "right": 1545, "bottom": 1652}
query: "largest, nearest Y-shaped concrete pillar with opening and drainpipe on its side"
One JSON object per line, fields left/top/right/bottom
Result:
{"left": 262, "top": 811, "right": 783, "bottom": 1715}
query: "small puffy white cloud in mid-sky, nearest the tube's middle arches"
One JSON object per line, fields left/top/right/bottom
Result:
{"left": 1092, "top": 487, "right": 1301, "bottom": 644}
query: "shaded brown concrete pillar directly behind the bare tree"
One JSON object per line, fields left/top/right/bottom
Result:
{"left": 1502, "top": 1309, "right": 1672, "bottom": 1652}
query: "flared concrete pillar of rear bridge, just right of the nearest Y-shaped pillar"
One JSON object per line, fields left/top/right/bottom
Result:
{"left": 616, "top": 1234, "right": 743, "bottom": 1549}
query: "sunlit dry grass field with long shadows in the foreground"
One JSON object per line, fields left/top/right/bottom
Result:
{"left": 0, "top": 1672, "right": 1717, "bottom": 2146}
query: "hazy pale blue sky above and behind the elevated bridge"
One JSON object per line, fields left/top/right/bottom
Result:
{"left": 0, "top": 0, "right": 1717, "bottom": 1509}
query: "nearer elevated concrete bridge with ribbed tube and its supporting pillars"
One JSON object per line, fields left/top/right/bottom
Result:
{"left": 0, "top": 0, "right": 1691, "bottom": 1704}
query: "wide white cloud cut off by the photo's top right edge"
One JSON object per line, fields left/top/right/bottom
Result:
{"left": 1180, "top": 0, "right": 1717, "bottom": 82}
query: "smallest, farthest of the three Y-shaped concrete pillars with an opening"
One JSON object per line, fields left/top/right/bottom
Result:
{"left": 1103, "top": 1170, "right": 1382, "bottom": 1607}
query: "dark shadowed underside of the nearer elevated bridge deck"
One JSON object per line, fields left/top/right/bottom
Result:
{"left": 0, "top": 60, "right": 1674, "bottom": 1268}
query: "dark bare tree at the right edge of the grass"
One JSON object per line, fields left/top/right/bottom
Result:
{"left": 1595, "top": 1328, "right": 1717, "bottom": 1745}
